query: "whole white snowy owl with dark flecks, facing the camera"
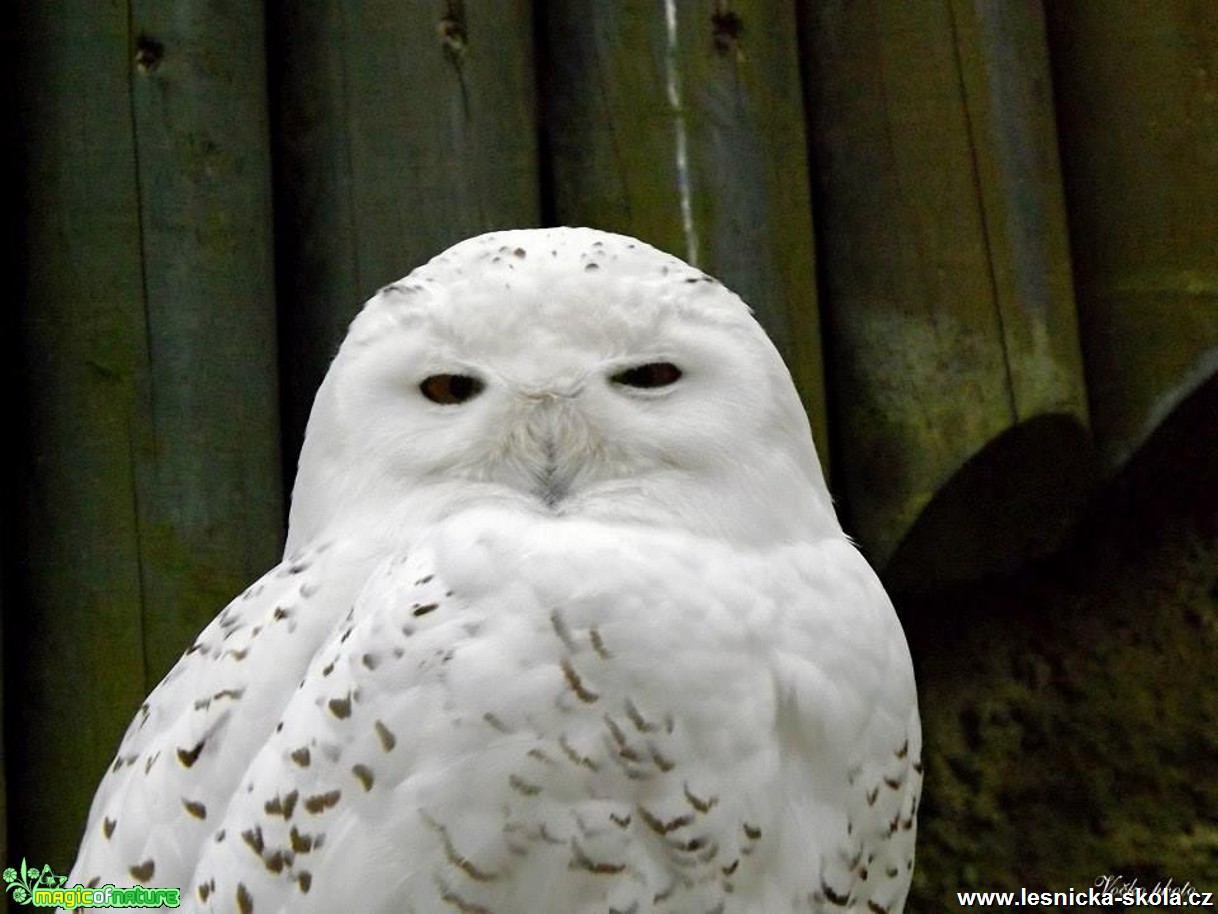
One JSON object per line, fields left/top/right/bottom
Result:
{"left": 67, "top": 228, "right": 922, "bottom": 914}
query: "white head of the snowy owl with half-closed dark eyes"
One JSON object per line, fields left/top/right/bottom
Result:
{"left": 287, "top": 228, "right": 840, "bottom": 551}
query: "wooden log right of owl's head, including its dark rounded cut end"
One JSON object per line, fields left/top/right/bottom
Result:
{"left": 803, "top": 0, "right": 1086, "bottom": 584}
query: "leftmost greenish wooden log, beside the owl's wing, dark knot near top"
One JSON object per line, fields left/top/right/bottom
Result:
{"left": 10, "top": 0, "right": 283, "bottom": 873}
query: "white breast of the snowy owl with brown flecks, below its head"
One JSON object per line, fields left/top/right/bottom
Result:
{"left": 190, "top": 511, "right": 915, "bottom": 912}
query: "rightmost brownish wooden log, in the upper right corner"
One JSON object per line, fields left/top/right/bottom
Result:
{"left": 1046, "top": 0, "right": 1218, "bottom": 469}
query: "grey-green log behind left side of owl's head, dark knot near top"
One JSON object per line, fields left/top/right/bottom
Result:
{"left": 270, "top": 0, "right": 540, "bottom": 467}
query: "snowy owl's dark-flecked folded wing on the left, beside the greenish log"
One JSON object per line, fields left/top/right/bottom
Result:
{"left": 68, "top": 541, "right": 367, "bottom": 901}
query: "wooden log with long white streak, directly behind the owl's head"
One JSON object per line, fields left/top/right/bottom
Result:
{"left": 543, "top": 0, "right": 828, "bottom": 461}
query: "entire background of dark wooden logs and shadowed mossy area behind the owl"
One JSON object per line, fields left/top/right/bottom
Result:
{"left": 0, "top": 0, "right": 1218, "bottom": 912}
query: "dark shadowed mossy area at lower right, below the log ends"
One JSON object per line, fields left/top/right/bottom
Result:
{"left": 896, "top": 379, "right": 1218, "bottom": 912}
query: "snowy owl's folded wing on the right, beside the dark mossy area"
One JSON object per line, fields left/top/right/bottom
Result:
{"left": 777, "top": 539, "right": 922, "bottom": 914}
